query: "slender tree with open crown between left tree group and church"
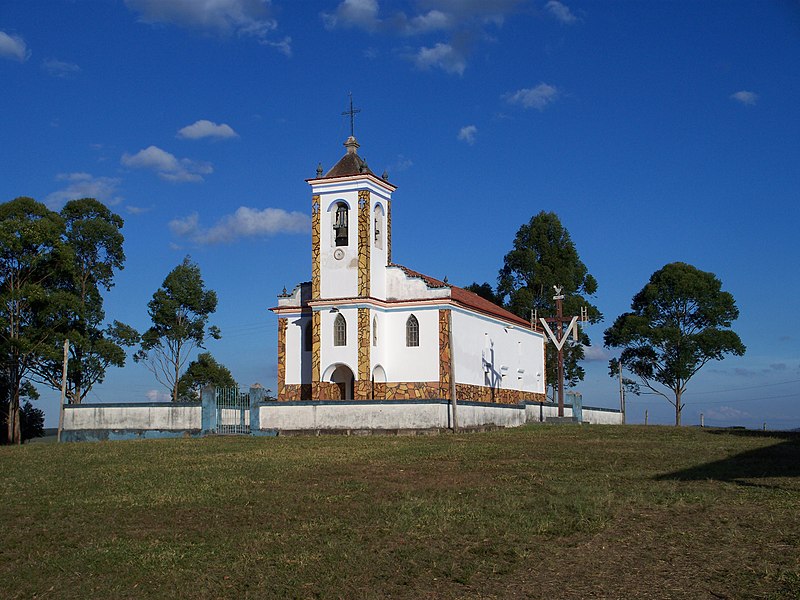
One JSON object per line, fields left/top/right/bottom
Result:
{"left": 133, "top": 256, "right": 220, "bottom": 402}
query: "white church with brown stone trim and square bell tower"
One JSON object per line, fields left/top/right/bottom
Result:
{"left": 271, "top": 135, "right": 545, "bottom": 404}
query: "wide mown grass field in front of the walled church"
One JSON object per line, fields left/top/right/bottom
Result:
{"left": 0, "top": 425, "right": 800, "bottom": 599}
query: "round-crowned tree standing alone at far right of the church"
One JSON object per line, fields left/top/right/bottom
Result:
{"left": 604, "top": 262, "right": 745, "bottom": 425}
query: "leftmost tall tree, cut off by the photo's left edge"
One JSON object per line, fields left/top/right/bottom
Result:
{"left": 0, "top": 197, "right": 67, "bottom": 444}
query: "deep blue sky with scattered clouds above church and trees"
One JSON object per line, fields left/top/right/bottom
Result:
{"left": 0, "top": 0, "right": 800, "bottom": 428}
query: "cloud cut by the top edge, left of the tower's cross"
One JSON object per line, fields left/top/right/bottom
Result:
{"left": 125, "top": 0, "right": 291, "bottom": 54}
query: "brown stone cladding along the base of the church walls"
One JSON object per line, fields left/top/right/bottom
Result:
{"left": 278, "top": 381, "right": 547, "bottom": 404}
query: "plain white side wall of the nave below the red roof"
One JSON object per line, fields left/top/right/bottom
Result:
{"left": 453, "top": 310, "right": 544, "bottom": 393}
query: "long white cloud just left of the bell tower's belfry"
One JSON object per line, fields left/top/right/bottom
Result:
{"left": 169, "top": 206, "right": 311, "bottom": 244}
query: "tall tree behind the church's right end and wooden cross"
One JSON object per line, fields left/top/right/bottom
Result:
{"left": 497, "top": 211, "right": 603, "bottom": 398}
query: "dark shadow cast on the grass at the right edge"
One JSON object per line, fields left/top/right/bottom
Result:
{"left": 655, "top": 429, "right": 800, "bottom": 490}
